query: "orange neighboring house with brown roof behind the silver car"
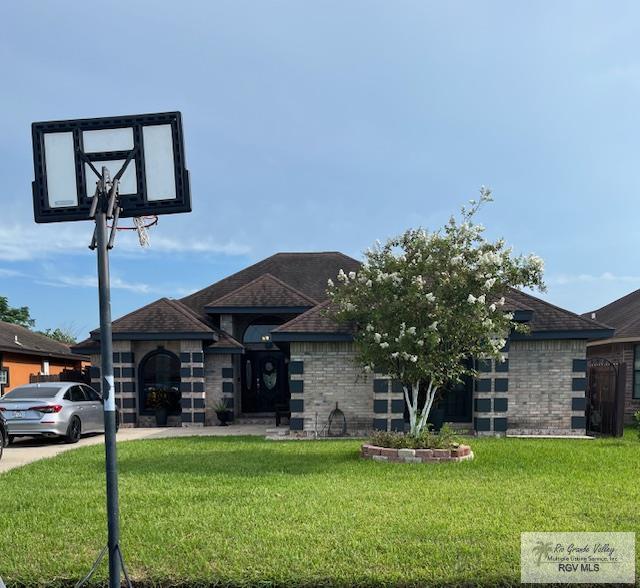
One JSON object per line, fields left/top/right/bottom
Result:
{"left": 0, "top": 321, "right": 89, "bottom": 395}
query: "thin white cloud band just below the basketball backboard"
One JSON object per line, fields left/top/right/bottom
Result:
{"left": 0, "top": 223, "right": 250, "bottom": 261}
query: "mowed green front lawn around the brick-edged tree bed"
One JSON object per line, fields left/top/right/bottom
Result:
{"left": 0, "top": 431, "right": 640, "bottom": 586}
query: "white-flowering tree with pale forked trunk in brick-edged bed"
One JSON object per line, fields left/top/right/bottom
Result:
{"left": 328, "top": 187, "right": 544, "bottom": 435}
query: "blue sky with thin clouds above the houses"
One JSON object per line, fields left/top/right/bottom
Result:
{"left": 0, "top": 0, "right": 640, "bottom": 337}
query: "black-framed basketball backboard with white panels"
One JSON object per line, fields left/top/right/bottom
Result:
{"left": 31, "top": 112, "right": 191, "bottom": 223}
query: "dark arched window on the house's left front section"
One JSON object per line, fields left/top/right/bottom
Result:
{"left": 138, "top": 349, "right": 182, "bottom": 415}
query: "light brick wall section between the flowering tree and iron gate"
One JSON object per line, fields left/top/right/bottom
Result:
{"left": 506, "top": 339, "right": 586, "bottom": 435}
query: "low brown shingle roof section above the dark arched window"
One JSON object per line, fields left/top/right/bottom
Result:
{"left": 91, "top": 298, "right": 214, "bottom": 337}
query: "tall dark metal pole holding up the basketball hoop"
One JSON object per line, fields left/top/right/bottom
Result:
{"left": 76, "top": 164, "right": 131, "bottom": 588}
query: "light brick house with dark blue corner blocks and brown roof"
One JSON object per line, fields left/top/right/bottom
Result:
{"left": 75, "top": 252, "right": 612, "bottom": 434}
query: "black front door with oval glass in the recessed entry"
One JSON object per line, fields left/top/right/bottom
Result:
{"left": 242, "top": 350, "right": 288, "bottom": 413}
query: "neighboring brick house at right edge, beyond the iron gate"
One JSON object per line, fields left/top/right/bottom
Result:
{"left": 583, "top": 290, "right": 640, "bottom": 423}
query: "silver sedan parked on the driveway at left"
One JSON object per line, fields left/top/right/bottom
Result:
{"left": 0, "top": 382, "right": 117, "bottom": 443}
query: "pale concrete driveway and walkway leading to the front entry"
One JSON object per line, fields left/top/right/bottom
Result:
{"left": 0, "top": 425, "right": 269, "bottom": 473}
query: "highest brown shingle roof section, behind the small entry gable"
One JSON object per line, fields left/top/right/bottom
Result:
{"left": 180, "top": 251, "right": 360, "bottom": 315}
